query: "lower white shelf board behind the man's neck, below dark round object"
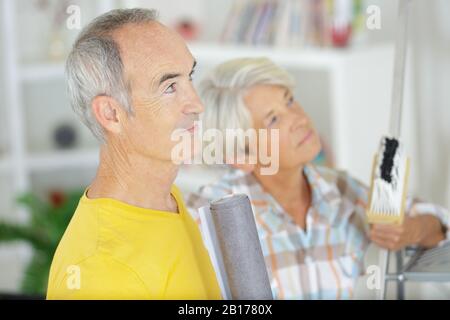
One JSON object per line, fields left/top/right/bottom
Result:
{"left": 26, "top": 149, "right": 99, "bottom": 172}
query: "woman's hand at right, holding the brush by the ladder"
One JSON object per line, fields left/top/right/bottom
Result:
{"left": 370, "top": 214, "right": 445, "bottom": 251}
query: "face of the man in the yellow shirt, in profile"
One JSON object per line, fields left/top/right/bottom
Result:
{"left": 113, "top": 22, "right": 203, "bottom": 161}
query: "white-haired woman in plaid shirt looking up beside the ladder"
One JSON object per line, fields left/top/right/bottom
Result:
{"left": 187, "top": 58, "right": 450, "bottom": 299}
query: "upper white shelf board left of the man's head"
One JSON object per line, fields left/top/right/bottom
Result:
{"left": 20, "top": 62, "right": 64, "bottom": 82}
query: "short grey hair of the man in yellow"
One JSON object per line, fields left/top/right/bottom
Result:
{"left": 66, "top": 8, "right": 158, "bottom": 142}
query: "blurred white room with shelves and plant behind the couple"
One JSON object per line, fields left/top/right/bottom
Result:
{"left": 0, "top": 0, "right": 450, "bottom": 299}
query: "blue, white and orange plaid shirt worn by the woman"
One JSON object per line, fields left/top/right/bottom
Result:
{"left": 186, "top": 165, "right": 450, "bottom": 299}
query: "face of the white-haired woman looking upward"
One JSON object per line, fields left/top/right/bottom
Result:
{"left": 244, "top": 85, "right": 321, "bottom": 169}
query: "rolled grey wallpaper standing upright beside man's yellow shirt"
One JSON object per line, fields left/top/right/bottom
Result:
{"left": 210, "top": 194, "right": 273, "bottom": 300}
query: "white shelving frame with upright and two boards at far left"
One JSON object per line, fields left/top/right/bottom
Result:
{"left": 0, "top": 0, "right": 116, "bottom": 193}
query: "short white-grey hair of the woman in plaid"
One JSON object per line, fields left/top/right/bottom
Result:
{"left": 199, "top": 58, "right": 295, "bottom": 154}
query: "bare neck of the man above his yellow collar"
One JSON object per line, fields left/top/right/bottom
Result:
{"left": 87, "top": 146, "right": 178, "bottom": 212}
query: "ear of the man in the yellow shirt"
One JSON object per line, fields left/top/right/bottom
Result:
{"left": 91, "top": 96, "right": 123, "bottom": 133}
